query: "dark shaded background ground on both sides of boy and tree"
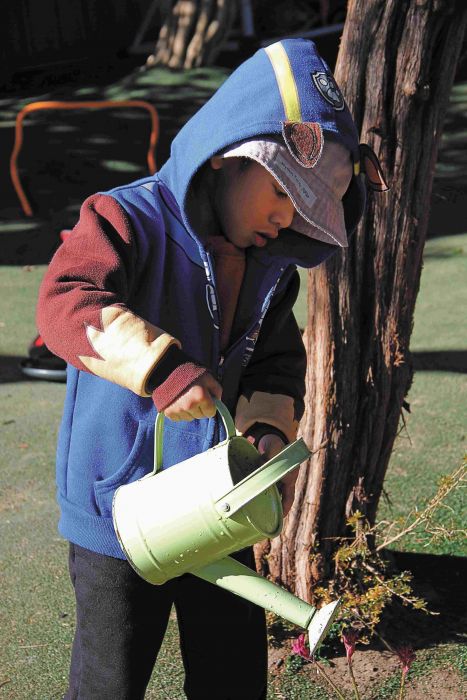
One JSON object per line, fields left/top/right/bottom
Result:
{"left": 0, "top": 38, "right": 467, "bottom": 265}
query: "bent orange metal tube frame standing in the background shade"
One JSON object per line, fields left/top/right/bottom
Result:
{"left": 10, "top": 100, "right": 159, "bottom": 216}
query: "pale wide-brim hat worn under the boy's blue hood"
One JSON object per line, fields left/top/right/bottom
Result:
{"left": 220, "top": 136, "right": 353, "bottom": 247}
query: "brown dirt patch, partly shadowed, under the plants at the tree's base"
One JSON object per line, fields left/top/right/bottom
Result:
{"left": 269, "top": 552, "right": 467, "bottom": 700}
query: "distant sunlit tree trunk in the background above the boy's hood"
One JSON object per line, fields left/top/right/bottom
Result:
{"left": 148, "top": 0, "right": 236, "bottom": 68}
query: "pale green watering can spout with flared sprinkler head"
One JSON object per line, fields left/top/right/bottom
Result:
{"left": 191, "top": 557, "right": 339, "bottom": 654}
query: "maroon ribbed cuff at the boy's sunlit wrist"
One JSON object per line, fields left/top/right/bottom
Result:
{"left": 146, "top": 345, "right": 207, "bottom": 411}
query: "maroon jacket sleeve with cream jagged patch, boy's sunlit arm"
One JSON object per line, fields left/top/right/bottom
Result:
{"left": 37, "top": 195, "right": 199, "bottom": 398}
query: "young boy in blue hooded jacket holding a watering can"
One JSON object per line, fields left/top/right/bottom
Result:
{"left": 38, "top": 40, "right": 364, "bottom": 700}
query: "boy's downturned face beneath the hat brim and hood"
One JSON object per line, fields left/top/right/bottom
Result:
{"left": 211, "top": 156, "right": 295, "bottom": 248}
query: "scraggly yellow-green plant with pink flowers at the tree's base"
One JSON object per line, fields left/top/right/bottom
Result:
{"left": 288, "top": 459, "right": 467, "bottom": 700}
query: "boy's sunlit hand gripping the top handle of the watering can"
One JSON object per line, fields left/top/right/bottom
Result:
{"left": 164, "top": 372, "right": 222, "bottom": 421}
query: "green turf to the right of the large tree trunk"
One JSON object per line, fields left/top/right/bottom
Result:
{"left": 378, "top": 234, "right": 467, "bottom": 556}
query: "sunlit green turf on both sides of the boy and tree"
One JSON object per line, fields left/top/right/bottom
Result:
{"left": 0, "top": 235, "right": 467, "bottom": 700}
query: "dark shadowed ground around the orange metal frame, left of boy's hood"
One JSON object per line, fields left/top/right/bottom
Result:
{"left": 0, "top": 63, "right": 229, "bottom": 265}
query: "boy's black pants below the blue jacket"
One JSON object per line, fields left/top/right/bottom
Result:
{"left": 65, "top": 544, "right": 267, "bottom": 700}
